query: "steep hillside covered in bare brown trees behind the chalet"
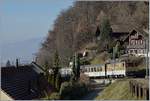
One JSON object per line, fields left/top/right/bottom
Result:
{"left": 38, "top": 1, "right": 149, "bottom": 66}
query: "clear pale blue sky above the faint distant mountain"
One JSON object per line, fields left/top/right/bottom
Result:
{"left": 0, "top": 0, "right": 73, "bottom": 43}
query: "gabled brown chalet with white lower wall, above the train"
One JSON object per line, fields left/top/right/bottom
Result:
{"left": 123, "top": 30, "right": 148, "bottom": 56}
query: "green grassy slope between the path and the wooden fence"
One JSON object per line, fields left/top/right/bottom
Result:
{"left": 95, "top": 79, "right": 137, "bottom": 100}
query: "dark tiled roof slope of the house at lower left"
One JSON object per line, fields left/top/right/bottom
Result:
{"left": 1, "top": 65, "right": 38, "bottom": 100}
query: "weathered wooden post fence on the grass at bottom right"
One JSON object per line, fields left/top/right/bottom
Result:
{"left": 129, "top": 80, "right": 149, "bottom": 100}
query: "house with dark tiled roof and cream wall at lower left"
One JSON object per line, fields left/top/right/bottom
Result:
{"left": 1, "top": 63, "right": 46, "bottom": 100}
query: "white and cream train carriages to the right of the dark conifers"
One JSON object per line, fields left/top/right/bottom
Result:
{"left": 81, "top": 62, "right": 126, "bottom": 77}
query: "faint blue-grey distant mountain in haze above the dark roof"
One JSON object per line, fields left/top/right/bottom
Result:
{"left": 1, "top": 38, "right": 44, "bottom": 64}
